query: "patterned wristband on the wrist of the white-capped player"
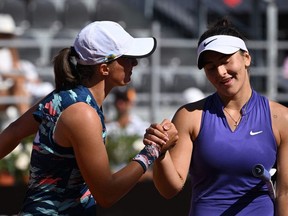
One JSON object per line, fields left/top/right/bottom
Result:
{"left": 132, "top": 145, "right": 160, "bottom": 173}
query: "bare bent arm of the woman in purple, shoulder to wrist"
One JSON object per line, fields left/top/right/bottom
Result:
{"left": 153, "top": 106, "right": 201, "bottom": 199}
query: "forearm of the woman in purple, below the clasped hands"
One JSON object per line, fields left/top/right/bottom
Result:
{"left": 153, "top": 151, "right": 186, "bottom": 199}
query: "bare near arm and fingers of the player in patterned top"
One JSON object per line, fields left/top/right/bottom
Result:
{"left": 54, "top": 103, "right": 177, "bottom": 207}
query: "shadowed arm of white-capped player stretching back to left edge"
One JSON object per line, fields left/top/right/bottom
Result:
{"left": 0, "top": 103, "right": 39, "bottom": 159}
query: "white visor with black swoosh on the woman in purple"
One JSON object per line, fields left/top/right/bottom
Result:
{"left": 197, "top": 35, "right": 248, "bottom": 69}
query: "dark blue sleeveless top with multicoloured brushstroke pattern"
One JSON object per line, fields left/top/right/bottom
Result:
{"left": 19, "top": 86, "right": 106, "bottom": 216}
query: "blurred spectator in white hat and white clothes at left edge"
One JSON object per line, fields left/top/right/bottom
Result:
{"left": 0, "top": 14, "right": 53, "bottom": 128}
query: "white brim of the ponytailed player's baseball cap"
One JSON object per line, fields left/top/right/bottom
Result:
{"left": 123, "top": 37, "right": 157, "bottom": 58}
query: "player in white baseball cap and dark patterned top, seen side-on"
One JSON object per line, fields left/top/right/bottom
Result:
{"left": 0, "top": 21, "right": 177, "bottom": 215}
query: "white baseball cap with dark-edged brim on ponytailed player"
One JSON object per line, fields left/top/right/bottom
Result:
{"left": 74, "top": 21, "right": 157, "bottom": 65}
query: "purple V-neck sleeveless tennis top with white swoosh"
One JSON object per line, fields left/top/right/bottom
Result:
{"left": 189, "top": 90, "right": 277, "bottom": 216}
